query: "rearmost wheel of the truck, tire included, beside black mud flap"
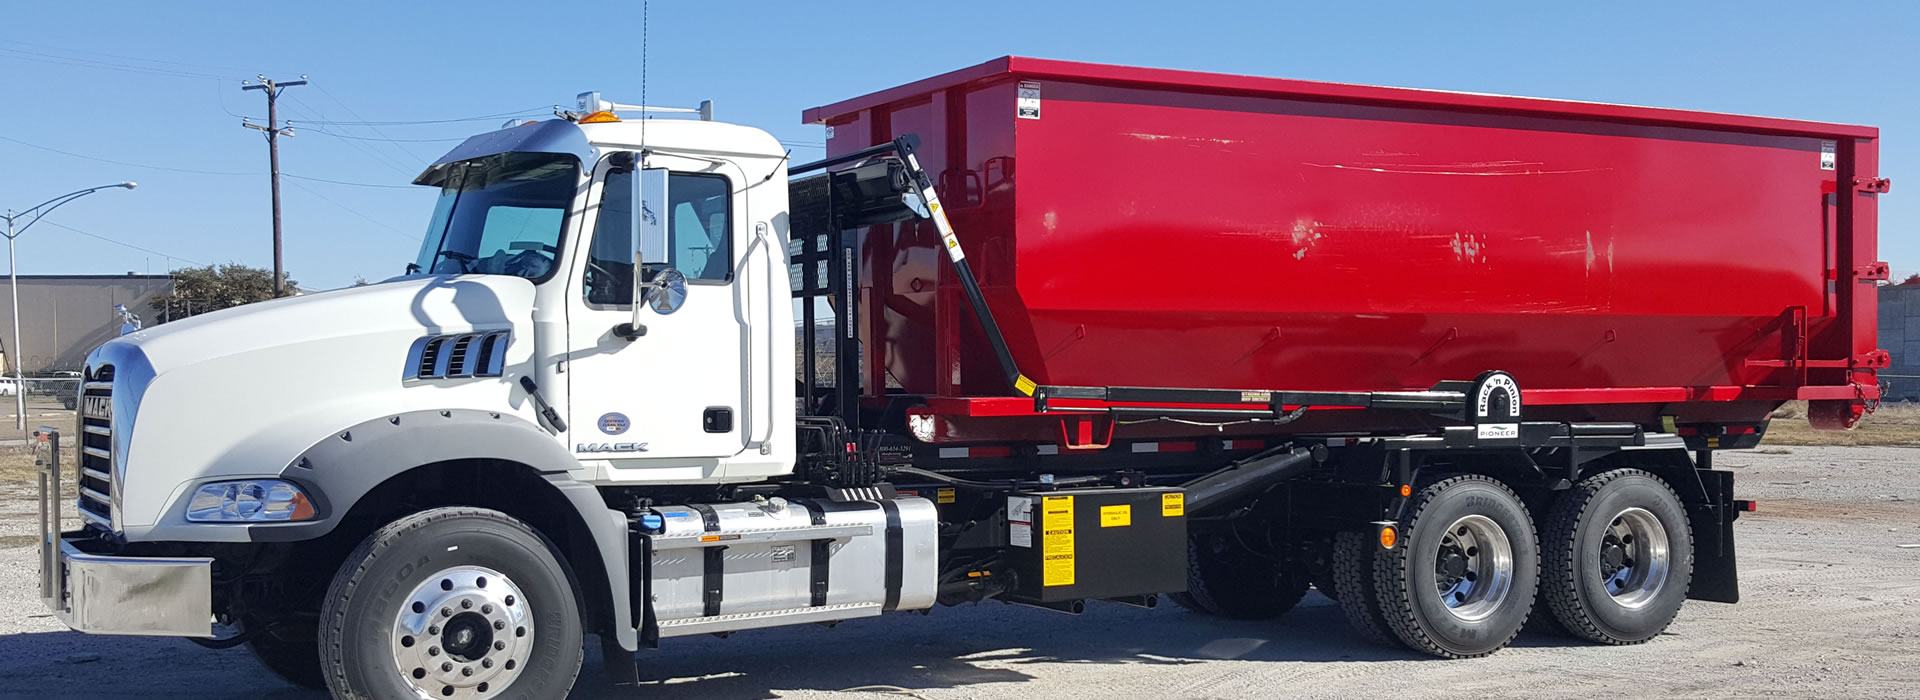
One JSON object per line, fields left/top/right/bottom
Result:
{"left": 1540, "top": 470, "right": 1693, "bottom": 644}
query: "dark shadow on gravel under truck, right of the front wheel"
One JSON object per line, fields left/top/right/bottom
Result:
{"left": 610, "top": 595, "right": 1572, "bottom": 700}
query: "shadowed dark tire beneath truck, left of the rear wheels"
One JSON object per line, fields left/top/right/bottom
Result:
{"left": 1171, "top": 533, "right": 1311, "bottom": 619}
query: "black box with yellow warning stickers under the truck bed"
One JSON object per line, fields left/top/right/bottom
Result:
{"left": 1006, "top": 487, "right": 1187, "bottom": 602}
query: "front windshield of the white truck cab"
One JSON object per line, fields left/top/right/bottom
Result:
{"left": 409, "top": 153, "right": 580, "bottom": 280}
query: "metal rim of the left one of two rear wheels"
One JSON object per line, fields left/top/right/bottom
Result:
{"left": 1434, "top": 516, "right": 1513, "bottom": 621}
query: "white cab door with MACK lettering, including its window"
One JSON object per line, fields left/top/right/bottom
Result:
{"left": 564, "top": 155, "right": 747, "bottom": 471}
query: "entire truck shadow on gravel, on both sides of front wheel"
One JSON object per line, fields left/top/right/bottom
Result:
{"left": 0, "top": 595, "right": 1572, "bottom": 700}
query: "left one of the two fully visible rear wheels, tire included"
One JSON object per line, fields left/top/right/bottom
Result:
{"left": 1373, "top": 474, "right": 1540, "bottom": 658}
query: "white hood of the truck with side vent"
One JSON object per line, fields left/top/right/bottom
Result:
{"left": 86, "top": 274, "right": 536, "bottom": 533}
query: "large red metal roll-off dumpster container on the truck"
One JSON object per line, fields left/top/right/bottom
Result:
{"left": 804, "top": 58, "right": 1878, "bottom": 433}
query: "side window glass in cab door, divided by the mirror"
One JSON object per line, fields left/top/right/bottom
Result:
{"left": 584, "top": 173, "right": 733, "bottom": 305}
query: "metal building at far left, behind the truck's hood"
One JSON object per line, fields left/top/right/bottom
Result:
{"left": 0, "top": 274, "right": 173, "bottom": 374}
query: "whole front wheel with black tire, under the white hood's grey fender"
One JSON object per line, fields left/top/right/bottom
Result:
{"left": 321, "top": 508, "right": 584, "bottom": 700}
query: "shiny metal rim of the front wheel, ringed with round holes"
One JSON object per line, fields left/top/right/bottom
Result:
{"left": 390, "top": 566, "right": 534, "bottom": 700}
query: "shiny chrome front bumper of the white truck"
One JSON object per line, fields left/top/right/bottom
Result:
{"left": 40, "top": 427, "right": 213, "bottom": 637}
